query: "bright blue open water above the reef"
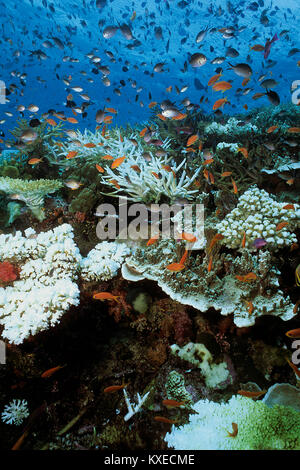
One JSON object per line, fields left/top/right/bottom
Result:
{"left": 0, "top": 0, "right": 300, "bottom": 137}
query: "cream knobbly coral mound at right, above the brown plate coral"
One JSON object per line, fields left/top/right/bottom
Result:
{"left": 216, "top": 186, "right": 300, "bottom": 249}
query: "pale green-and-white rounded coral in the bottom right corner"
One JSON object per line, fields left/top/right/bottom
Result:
{"left": 165, "top": 395, "right": 300, "bottom": 450}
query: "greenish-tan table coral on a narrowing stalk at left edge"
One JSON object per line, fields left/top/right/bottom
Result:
{"left": 0, "top": 177, "right": 63, "bottom": 221}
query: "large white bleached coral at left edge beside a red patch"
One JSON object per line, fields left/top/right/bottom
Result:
{"left": 0, "top": 224, "right": 81, "bottom": 344}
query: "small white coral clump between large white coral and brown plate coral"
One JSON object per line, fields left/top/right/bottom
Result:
{"left": 81, "top": 241, "right": 130, "bottom": 281}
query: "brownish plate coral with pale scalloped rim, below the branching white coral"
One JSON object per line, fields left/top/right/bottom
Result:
{"left": 122, "top": 240, "right": 295, "bottom": 327}
